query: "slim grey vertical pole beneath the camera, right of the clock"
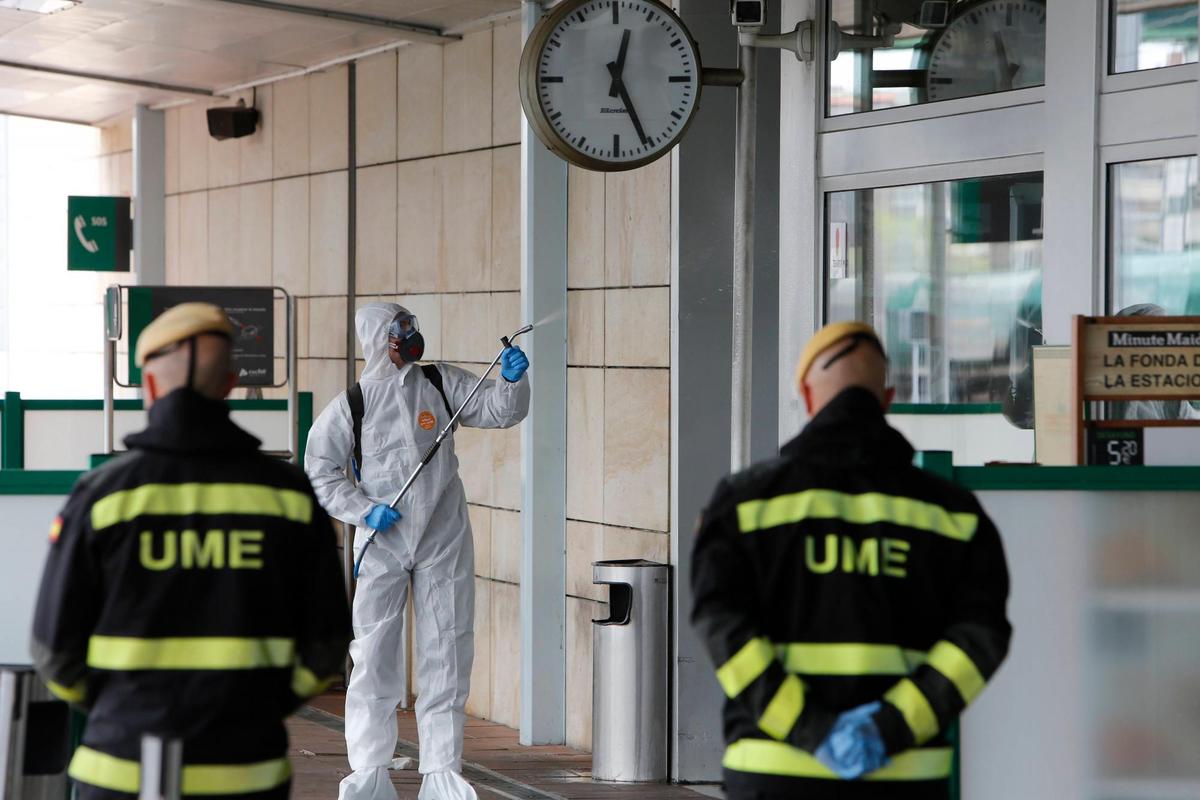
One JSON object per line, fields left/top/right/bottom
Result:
{"left": 730, "top": 43, "right": 758, "bottom": 473}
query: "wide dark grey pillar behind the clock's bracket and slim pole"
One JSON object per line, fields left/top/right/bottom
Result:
{"left": 671, "top": 0, "right": 792, "bottom": 782}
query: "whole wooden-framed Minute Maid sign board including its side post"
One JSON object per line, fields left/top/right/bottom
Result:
{"left": 1072, "top": 317, "right": 1200, "bottom": 464}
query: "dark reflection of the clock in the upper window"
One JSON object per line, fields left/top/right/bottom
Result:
{"left": 925, "top": 0, "right": 1046, "bottom": 101}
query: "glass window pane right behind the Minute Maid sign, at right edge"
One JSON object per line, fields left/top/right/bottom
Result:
{"left": 1109, "top": 156, "right": 1200, "bottom": 315}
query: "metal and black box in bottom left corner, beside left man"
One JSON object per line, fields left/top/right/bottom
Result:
{"left": 0, "top": 666, "right": 71, "bottom": 800}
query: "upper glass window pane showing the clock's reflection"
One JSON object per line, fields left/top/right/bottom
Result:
{"left": 827, "top": 0, "right": 1046, "bottom": 116}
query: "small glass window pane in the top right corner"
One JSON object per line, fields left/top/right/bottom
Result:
{"left": 1111, "top": 0, "right": 1200, "bottom": 72}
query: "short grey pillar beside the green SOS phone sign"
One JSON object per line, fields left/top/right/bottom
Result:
{"left": 133, "top": 106, "right": 167, "bottom": 285}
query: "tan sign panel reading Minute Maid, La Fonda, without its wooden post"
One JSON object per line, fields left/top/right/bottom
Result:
{"left": 1082, "top": 317, "right": 1200, "bottom": 401}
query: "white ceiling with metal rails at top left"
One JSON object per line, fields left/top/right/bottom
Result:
{"left": 0, "top": 0, "right": 520, "bottom": 124}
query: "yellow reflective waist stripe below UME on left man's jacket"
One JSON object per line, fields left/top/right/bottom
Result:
{"left": 88, "top": 636, "right": 295, "bottom": 669}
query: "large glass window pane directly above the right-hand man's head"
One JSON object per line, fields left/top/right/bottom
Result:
{"left": 826, "top": 173, "right": 1042, "bottom": 417}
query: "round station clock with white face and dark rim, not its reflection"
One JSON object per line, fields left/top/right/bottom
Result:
{"left": 521, "top": 0, "right": 700, "bottom": 170}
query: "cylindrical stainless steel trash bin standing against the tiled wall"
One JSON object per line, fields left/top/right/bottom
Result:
{"left": 592, "top": 559, "right": 671, "bottom": 782}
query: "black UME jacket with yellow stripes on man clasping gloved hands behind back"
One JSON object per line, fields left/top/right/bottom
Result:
{"left": 691, "top": 389, "right": 1012, "bottom": 800}
